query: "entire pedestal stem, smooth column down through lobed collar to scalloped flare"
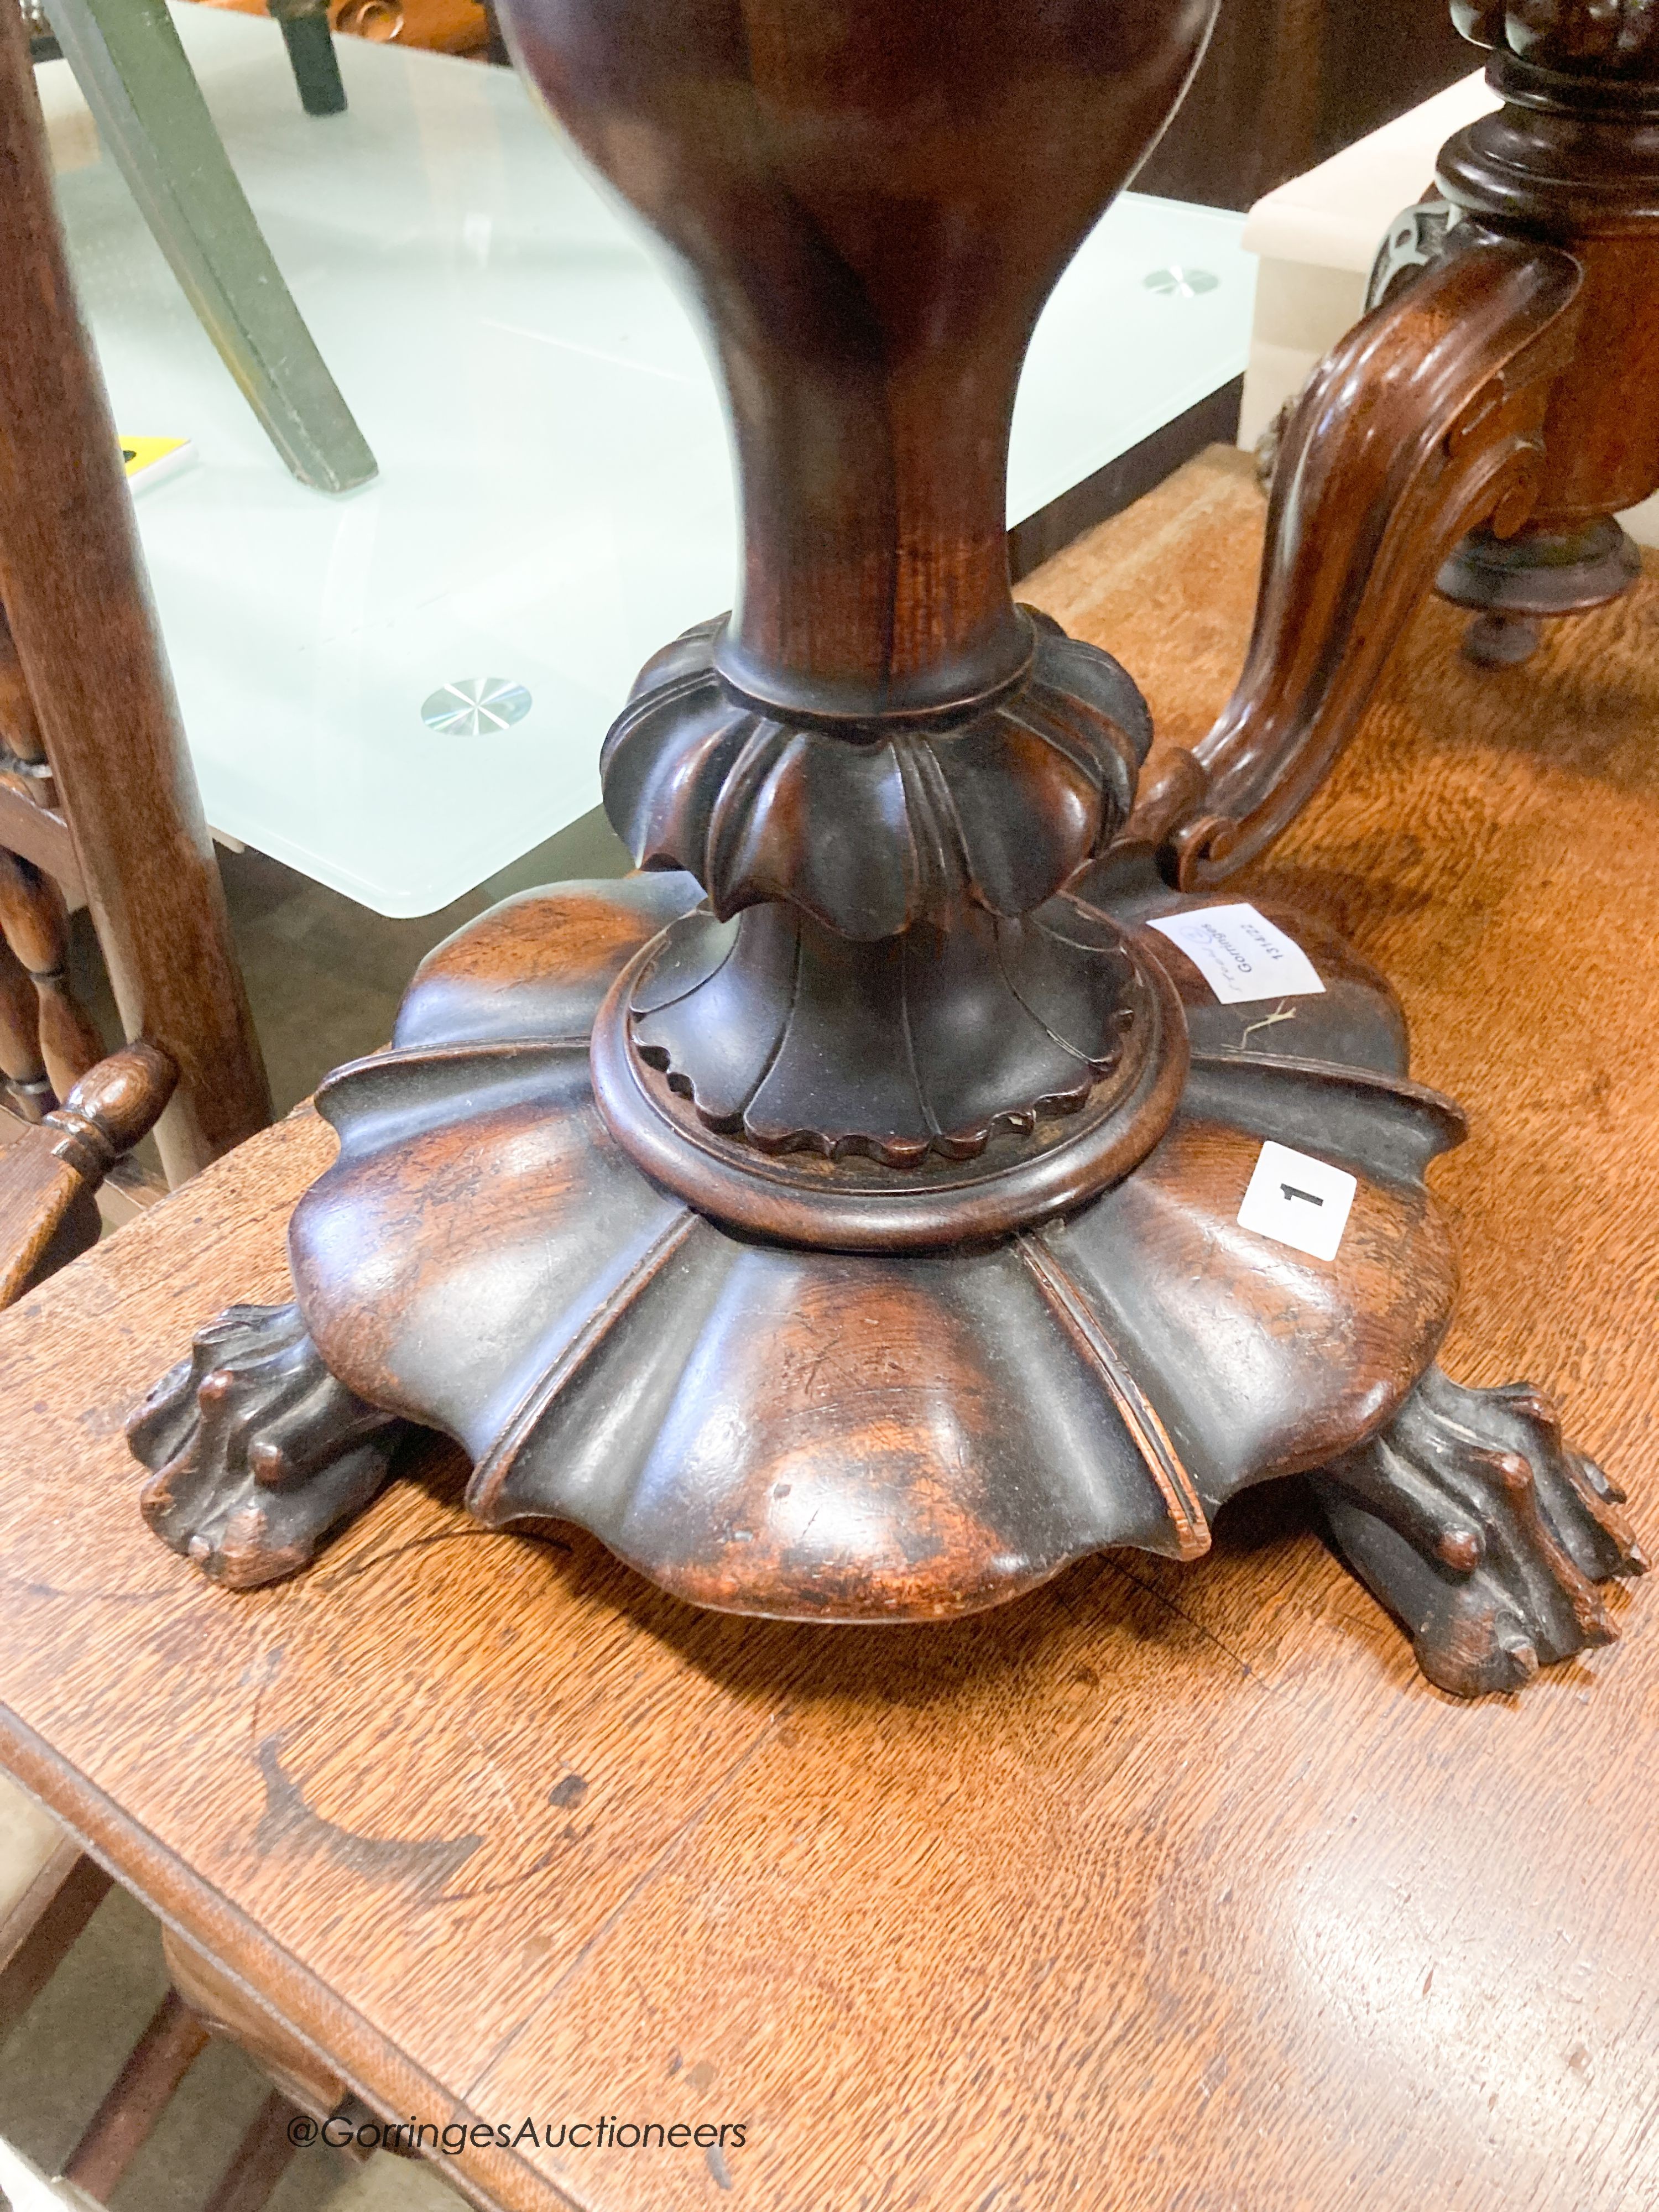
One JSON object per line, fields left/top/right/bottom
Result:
{"left": 504, "top": 0, "right": 1212, "bottom": 1166}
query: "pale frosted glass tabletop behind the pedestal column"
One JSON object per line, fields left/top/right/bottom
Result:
{"left": 38, "top": 4, "right": 1254, "bottom": 916}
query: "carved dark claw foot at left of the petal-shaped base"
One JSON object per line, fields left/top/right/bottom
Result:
{"left": 126, "top": 1305, "right": 409, "bottom": 1590}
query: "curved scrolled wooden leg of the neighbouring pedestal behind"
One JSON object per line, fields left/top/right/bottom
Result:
{"left": 1124, "top": 223, "right": 1579, "bottom": 889}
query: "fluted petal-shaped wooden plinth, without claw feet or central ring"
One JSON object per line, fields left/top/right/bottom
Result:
{"left": 292, "top": 867, "right": 1460, "bottom": 1621}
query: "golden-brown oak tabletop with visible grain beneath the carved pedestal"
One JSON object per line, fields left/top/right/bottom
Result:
{"left": 0, "top": 456, "right": 1659, "bottom": 2212}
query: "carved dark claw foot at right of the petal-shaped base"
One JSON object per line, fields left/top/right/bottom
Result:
{"left": 1312, "top": 1367, "right": 1648, "bottom": 1697}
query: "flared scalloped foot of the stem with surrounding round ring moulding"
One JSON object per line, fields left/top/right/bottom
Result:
{"left": 584, "top": 872, "right": 1188, "bottom": 1252}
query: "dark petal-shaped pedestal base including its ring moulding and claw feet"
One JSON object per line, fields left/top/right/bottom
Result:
{"left": 131, "top": 860, "right": 1641, "bottom": 1694}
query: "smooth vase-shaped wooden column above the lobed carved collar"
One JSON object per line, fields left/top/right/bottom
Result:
{"left": 502, "top": 0, "right": 1214, "bottom": 717}
